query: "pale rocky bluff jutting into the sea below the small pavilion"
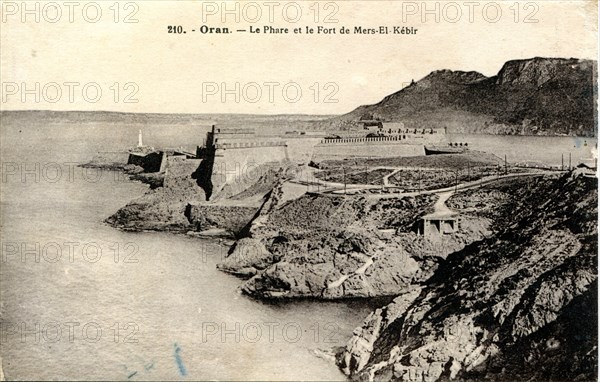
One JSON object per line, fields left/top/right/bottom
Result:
{"left": 219, "top": 188, "right": 490, "bottom": 299}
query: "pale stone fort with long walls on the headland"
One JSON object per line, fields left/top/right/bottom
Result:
{"left": 160, "top": 122, "right": 445, "bottom": 200}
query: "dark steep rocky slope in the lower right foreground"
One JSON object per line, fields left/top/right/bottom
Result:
{"left": 338, "top": 172, "right": 598, "bottom": 381}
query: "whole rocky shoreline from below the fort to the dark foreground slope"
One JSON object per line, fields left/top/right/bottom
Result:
{"left": 107, "top": 153, "right": 597, "bottom": 381}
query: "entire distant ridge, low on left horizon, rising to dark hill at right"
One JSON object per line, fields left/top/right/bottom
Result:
{"left": 0, "top": 57, "right": 598, "bottom": 137}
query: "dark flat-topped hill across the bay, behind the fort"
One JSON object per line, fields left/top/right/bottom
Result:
{"left": 337, "top": 57, "right": 598, "bottom": 136}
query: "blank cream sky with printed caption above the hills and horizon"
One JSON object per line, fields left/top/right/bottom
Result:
{"left": 0, "top": 0, "right": 598, "bottom": 114}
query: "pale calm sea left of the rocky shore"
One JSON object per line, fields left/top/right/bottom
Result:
{"left": 0, "top": 123, "right": 373, "bottom": 380}
